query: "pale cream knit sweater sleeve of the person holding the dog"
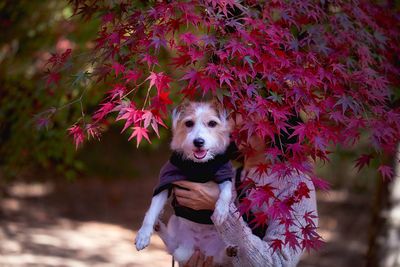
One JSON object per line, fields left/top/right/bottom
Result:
{"left": 211, "top": 177, "right": 317, "bottom": 267}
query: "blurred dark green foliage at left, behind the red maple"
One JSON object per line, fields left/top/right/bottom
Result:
{"left": 0, "top": 0, "right": 98, "bottom": 178}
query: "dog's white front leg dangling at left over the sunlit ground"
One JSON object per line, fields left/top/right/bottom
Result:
{"left": 135, "top": 190, "right": 168, "bottom": 250}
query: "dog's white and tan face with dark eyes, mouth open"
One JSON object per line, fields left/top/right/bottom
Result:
{"left": 171, "top": 102, "right": 230, "bottom": 162}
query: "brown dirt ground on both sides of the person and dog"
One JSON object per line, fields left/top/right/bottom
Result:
{"left": 0, "top": 175, "right": 369, "bottom": 267}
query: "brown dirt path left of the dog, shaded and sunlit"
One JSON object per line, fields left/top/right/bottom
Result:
{"left": 0, "top": 177, "right": 171, "bottom": 267}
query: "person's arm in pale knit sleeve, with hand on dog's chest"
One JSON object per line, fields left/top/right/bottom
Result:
{"left": 175, "top": 176, "right": 317, "bottom": 267}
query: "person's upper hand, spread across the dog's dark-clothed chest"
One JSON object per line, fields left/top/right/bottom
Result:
{"left": 173, "top": 181, "right": 219, "bottom": 210}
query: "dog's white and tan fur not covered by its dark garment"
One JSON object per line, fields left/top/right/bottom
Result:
{"left": 135, "top": 102, "right": 232, "bottom": 266}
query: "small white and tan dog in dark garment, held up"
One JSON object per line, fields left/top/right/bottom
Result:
{"left": 135, "top": 102, "right": 233, "bottom": 266}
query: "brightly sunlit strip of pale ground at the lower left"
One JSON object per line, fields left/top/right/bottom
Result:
{"left": 0, "top": 219, "right": 170, "bottom": 267}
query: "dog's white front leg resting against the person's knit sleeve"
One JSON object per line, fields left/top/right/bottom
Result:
{"left": 213, "top": 181, "right": 232, "bottom": 225}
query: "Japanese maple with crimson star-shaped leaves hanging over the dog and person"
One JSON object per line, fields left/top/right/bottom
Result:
{"left": 43, "top": 0, "right": 400, "bottom": 251}
